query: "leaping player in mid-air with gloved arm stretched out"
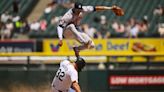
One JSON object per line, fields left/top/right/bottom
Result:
{"left": 57, "top": 3, "right": 124, "bottom": 57}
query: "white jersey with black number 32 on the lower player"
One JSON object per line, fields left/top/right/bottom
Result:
{"left": 52, "top": 60, "right": 78, "bottom": 92}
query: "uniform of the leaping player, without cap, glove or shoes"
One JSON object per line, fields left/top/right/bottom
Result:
{"left": 57, "top": 6, "right": 95, "bottom": 47}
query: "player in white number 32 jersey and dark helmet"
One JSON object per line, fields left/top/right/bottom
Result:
{"left": 52, "top": 57, "right": 85, "bottom": 92}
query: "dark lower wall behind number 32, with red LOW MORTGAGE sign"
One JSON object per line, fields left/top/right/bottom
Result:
{"left": 0, "top": 70, "right": 164, "bottom": 92}
